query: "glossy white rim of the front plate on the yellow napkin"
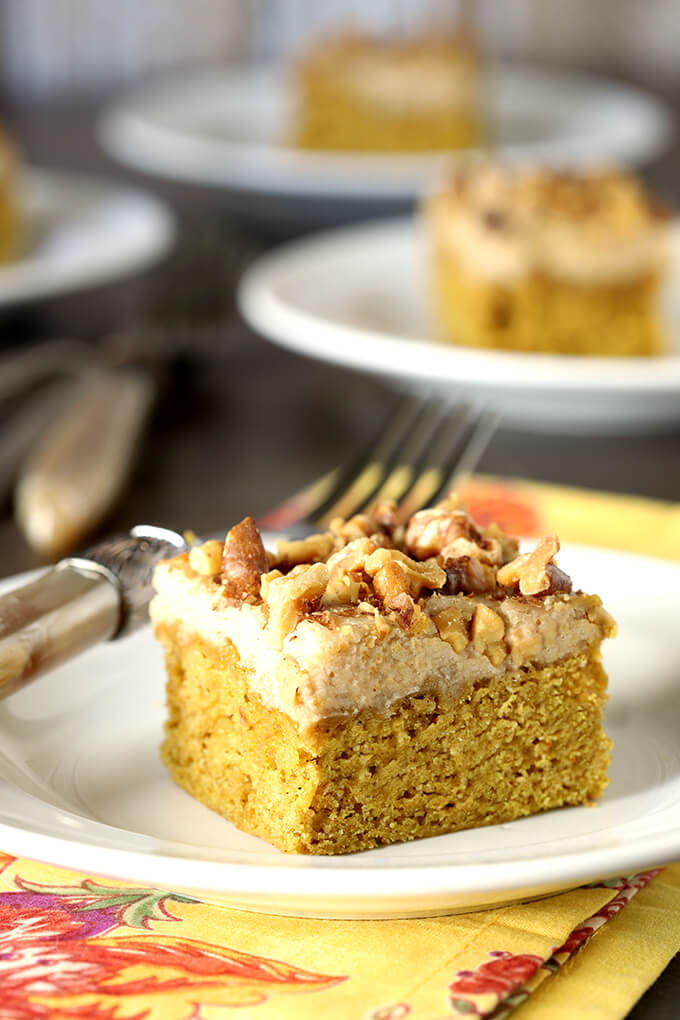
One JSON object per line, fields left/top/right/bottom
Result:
{"left": 0, "top": 547, "right": 680, "bottom": 917}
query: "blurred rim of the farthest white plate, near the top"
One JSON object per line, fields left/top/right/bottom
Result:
{"left": 98, "top": 64, "right": 673, "bottom": 201}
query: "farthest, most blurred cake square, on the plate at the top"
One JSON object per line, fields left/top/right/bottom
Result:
{"left": 294, "top": 35, "right": 482, "bottom": 152}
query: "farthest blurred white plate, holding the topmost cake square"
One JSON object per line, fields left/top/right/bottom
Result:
{"left": 101, "top": 66, "right": 672, "bottom": 211}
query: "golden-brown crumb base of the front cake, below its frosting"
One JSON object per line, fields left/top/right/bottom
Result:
{"left": 156, "top": 624, "right": 612, "bottom": 854}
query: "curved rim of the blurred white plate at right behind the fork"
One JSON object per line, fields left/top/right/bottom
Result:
{"left": 237, "top": 215, "right": 680, "bottom": 394}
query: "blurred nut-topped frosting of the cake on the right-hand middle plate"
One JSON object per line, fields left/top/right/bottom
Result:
{"left": 426, "top": 164, "right": 669, "bottom": 285}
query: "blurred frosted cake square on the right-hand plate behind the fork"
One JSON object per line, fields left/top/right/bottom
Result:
{"left": 425, "top": 161, "right": 670, "bottom": 356}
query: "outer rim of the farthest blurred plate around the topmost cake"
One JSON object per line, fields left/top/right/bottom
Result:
{"left": 97, "top": 60, "right": 674, "bottom": 202}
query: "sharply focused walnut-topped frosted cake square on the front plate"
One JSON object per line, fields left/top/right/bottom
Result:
{"left": 151, "top": 497, "right": 615, "bottom": 854}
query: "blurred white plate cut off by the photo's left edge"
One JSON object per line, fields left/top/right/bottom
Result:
{"left": 0, "top": 169, "right": 174, "bottom": 308}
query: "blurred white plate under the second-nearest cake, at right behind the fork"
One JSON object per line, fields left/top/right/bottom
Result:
{"left": 239, "top": 217, "right": 680, "bottom": 431}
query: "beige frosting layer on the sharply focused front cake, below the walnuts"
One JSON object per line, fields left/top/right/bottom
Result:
{"left": 151, "top": 557, "right": 613, "bottom": 728}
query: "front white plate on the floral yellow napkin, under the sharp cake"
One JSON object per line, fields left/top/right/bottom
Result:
{"left": 0, "top": 548, "right": 680, "bottom": 917}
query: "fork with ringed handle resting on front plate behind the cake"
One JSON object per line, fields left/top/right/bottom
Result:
{"left": 0, "top": 398, "right": 496, "bottom": 697}
